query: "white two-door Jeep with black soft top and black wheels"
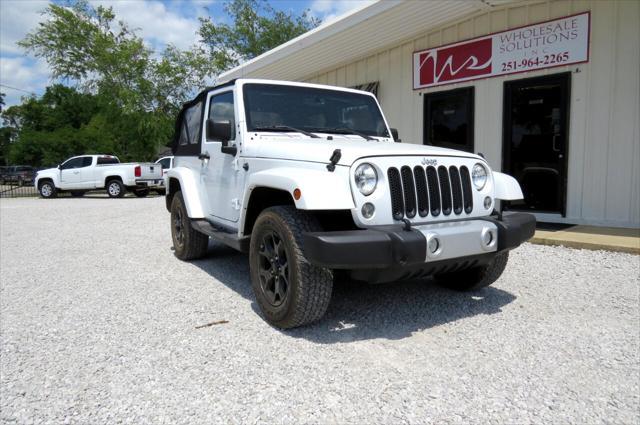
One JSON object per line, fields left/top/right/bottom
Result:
{"left": 166, "top": 79, "right": 535, "bottom": 328}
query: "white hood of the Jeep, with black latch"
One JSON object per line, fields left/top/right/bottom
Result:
{"left": 243, "top": 134, "right": 480, "bottom": 166}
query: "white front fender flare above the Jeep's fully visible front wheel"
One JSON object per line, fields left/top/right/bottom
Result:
{"left": 243, "top": 167, "right": 355, "bottom": 210}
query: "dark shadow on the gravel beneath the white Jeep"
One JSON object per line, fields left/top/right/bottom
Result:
{"left": 193, "top": 243, "right": 516, "bottom": 344}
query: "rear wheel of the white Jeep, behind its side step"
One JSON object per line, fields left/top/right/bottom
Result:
{"left": 171, "top": 191, "right": 209, "bottom": 261}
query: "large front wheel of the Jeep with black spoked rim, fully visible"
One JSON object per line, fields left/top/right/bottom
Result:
{"left": 249, "top": 206, "right": 333, "bottom": 329}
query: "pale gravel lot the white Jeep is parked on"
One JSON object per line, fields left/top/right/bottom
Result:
{"left": 0, "top": 196, "right": 640, "bottom": 424}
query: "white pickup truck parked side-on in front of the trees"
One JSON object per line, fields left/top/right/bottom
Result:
{"left": 35, "top": 155, "right": 163, "bottom": 198}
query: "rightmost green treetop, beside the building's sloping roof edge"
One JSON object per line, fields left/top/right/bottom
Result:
{"left": 198, "top": 0, "right": 320, "bottom": 71}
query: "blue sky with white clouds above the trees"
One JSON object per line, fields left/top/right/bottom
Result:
{"left": 0, "top": 0, "right": 371, "bottom": 106}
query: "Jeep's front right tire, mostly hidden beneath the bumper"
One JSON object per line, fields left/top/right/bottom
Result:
{"left": 435, "top": 251, "right": 509, "bottom": 291}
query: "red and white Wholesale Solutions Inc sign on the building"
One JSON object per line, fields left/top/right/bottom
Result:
{"left": 413, "top": 12, "right": 590, "bottom": 89}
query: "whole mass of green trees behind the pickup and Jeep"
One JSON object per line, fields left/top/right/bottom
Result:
{"left": 6, "top": 0, "right": 319, "bottom": 166}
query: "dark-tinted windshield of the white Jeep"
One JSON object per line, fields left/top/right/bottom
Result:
{"left": 244, "top": 84, "right": 389, "bottom": 137}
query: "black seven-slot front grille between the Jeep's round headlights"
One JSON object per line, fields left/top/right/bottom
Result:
{"left": 387, "top": 165, "right": 473, "bottom": 220}
